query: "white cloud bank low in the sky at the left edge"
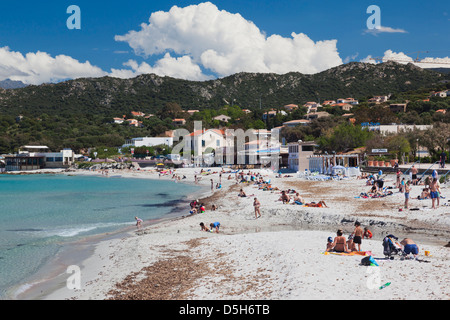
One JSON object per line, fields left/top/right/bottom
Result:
{"left": 0, "top": 47, "right": 106, "bottom": 84}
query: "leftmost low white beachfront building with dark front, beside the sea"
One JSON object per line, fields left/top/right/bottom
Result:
{"left": 5, "top": 146, "right": 75, "bottom": 171}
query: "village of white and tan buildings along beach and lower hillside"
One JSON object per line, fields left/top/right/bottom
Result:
{"left": 0, "top": 90, "right": 450, "bottom": 174}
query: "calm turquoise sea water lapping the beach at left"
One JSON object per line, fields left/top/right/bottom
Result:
{"left": 0, "top": 174, "right": 199, "bottom": 299}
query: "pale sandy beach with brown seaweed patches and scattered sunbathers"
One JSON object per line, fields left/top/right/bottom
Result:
{"left": 23, "top": 168, "right": 450, "bottom": 300}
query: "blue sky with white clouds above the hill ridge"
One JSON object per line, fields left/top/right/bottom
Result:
{"left": 0, "top": 0, "right": 450, "bottom": 84}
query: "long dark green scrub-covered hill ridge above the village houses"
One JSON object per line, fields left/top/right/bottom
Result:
{"left": 0, "top": 62, "right": 450, "bottom": 117}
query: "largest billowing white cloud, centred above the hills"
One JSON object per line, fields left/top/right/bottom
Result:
{"left": 115, "top": 2, "right": 342, "bottom": 78}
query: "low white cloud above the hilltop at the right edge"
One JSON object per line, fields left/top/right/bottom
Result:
{"left": 361, "top": 50, "right": 450, "bottom": 68}
